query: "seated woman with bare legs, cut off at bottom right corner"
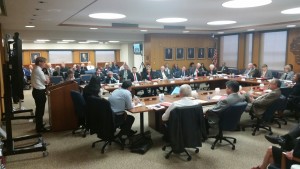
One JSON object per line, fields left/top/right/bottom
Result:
{"left": 252, "top": 140, "right": 300, "bottom": 169}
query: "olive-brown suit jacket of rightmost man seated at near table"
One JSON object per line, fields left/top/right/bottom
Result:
{"left": 252, "top": 89, "right": 281, "bottom": 115}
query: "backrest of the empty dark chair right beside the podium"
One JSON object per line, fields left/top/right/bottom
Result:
{"left": 70, "top": 90, "right": 86, "bottom": 118}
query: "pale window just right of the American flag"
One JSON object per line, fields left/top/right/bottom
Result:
{"left": 220, "top": 35, "right": 239, "bottom": 67}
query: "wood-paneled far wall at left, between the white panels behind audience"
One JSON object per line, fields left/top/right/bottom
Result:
{"left": 23, "top": 50, "right": 120, "bottom": 66}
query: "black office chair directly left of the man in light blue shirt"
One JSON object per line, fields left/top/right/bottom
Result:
{"left": 87, "top": 96, "right": 124, "bottom": 153}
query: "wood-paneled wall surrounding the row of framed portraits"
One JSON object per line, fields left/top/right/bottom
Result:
{"left": 144, "top": 34, "right": 215, "bottom": 69}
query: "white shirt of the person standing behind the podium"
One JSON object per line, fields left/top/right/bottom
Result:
{"left": 31, "top": 66, "right": 46, "bottom": 90}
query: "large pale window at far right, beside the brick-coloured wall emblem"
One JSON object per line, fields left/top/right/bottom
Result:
{"left": 260, "top": 31, "right": 287, "bottom": 70}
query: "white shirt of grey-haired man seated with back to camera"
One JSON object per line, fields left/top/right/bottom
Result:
{"left": 162, "top": 97, "right": 199, "bottom": 121}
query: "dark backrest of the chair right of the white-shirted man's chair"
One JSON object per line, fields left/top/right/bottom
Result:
{"left": 219, "top": 102, "right": 247, "bottom": 131}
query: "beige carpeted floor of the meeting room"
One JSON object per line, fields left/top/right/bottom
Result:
{"left": 2, "top": 90, "right": 297, "bottom": 169}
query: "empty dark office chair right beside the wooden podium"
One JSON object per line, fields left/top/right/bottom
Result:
{"left": 71, "top": 90, "right": 87, "bottom": 137}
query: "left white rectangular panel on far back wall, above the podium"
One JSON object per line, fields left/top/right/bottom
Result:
{"left": 49, "top": 51, "right": 73, "bottom": 63}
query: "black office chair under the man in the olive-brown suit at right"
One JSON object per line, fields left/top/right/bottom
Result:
{"left": 242, "top": 98, "right": 281, "bottom": 136}
